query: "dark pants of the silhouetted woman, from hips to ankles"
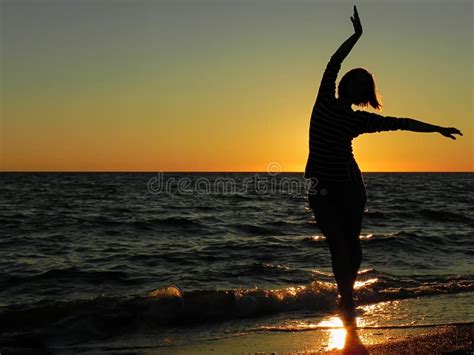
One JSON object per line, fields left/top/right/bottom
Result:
{"left": 308, "top": 182, "right": 367, "bottom": 307}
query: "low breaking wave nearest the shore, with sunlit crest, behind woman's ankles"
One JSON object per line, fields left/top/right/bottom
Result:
{"left": 0, "top": 272, "right": 474, "bottom": 333}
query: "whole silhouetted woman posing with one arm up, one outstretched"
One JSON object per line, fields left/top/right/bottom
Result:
{"left": 305, "top": 6, "right": 462, "bottom": 324}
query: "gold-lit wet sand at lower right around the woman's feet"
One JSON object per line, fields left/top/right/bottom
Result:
{"left": 164, "top": 323, "right": 474, "bottom": 355}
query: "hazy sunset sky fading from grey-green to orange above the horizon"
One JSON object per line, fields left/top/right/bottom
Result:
{"left": 0, "top": 0, "right": 474, "bottom": 171}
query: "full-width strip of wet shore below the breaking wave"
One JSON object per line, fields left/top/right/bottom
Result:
{"left": 0, "top": 323, "right": 474, "bottom": 355}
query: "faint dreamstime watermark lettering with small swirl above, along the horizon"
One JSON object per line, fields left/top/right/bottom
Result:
{"left": 147, "top": 162, "right": 318, "bottom": 196}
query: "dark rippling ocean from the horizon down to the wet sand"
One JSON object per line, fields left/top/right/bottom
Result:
{"left": 0, "top": 171, "right": 474, "bottom": 353}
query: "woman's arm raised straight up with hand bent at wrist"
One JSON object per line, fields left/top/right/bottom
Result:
{"left": 317, "top": 6, "right": 362, "bottom": 99}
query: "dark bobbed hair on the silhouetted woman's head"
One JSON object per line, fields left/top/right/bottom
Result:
{"left": 337, "top": 68, "right": 382, "bottom": 110}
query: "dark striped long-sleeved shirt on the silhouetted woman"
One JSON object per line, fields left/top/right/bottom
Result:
{"left": 304, "top": 56, "right": 408, "bottom": 183}
